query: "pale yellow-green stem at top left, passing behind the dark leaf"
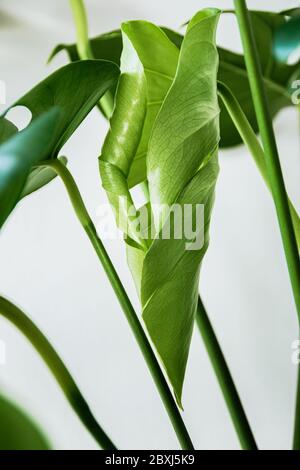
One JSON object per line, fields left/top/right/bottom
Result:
{"left": 70, "top": 0, "right": 114, "bottom": 119}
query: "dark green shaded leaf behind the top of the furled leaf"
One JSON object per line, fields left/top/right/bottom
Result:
{"left": 51, "top": 10, "right": 300, "bottom": 147}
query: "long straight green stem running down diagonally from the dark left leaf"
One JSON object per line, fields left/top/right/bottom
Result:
{"left": 41, "top": 160, "right": 193, "bottom": 450}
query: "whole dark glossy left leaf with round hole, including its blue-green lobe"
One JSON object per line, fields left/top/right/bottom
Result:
{"left": 0, "top": 60, "right": 119, "bottom": 226}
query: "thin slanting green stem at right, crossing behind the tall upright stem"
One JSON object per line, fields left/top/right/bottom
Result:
{"left": 218, "top": 82, "right": 300, "bottom": 251}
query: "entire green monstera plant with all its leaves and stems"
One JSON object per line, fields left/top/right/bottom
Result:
{"left": 0, "top": 0, "right": 300, "bottom": 450}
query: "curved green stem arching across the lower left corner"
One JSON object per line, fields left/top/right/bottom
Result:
{"left": 0, "top": 297, "right": 116, "bottom": 450}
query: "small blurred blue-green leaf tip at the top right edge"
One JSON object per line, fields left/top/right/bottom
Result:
{"left": 274, "top": 14, "right": 300, "bottom": 62}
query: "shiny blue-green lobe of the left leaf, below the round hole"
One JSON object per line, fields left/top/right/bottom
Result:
{"left": 0, "top": 108, "right": 60, "bottom": 227}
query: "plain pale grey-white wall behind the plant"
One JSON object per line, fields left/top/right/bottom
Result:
{"left": 0, "top": 0, "right": 300, "bottom": 449}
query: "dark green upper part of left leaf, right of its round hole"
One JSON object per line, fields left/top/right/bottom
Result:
{"left": 3, "top": 60, "right": 119, "bottom": 158}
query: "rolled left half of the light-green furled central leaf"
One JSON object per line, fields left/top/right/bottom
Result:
{"left": 100, "top": 21, "right": 179, "bottom": 243}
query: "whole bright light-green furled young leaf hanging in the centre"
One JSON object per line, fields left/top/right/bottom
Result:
{"left": 100, "top": 9, "right": 219, "bottom": 404}
